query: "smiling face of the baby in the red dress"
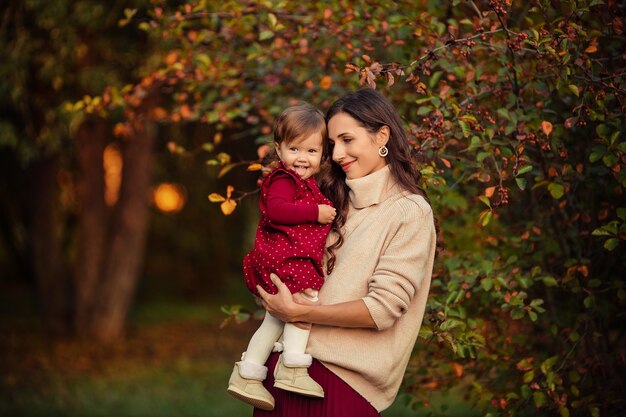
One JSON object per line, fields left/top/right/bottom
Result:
{"left": 274, "top": 133, "right": 323, "bottom": 180}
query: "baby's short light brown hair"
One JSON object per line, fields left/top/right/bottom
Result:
{"left": 274, "top": 103, "right": 328, "bottom": 146}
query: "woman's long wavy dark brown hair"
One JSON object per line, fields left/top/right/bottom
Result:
{"left": 320, "top": 88, "right": 430, "bottom": 274}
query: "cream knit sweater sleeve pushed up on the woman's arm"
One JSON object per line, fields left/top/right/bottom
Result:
{"left": 363, "top": 200, "right": 436, "bottom": 330}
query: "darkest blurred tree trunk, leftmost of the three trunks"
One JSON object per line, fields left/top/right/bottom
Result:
{"left": 26, "top": 158, "right": 70, "bottom": 336}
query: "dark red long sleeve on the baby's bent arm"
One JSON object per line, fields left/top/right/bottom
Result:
{"left": 267, "top": 175, "right": 318, "bottom": 225}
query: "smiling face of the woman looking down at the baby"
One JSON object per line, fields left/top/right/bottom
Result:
{"left": 328, "top": 113, "right": 389, "bottom": 179}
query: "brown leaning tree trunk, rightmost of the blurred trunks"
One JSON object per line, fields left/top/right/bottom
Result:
{"left": 92, "top": 119, "right": 155, "bottom": 343}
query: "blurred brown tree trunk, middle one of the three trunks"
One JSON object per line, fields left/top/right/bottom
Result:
{"left": 74, "top": 118, "right": 107, "bottom": 336}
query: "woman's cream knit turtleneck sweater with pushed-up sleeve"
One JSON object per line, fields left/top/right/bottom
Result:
{"left": 307, "top": 167, "right": 436, "bottom": 412}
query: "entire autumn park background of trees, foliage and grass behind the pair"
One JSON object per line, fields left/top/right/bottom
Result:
{"left": 0, "top": 0, "right": 626, "bottom": 417}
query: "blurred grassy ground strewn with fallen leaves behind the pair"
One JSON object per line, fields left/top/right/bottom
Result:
{"left": 0, "top": 290, "right": 476, "bottom": 417}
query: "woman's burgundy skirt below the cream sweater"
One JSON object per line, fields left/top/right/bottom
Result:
{"left": 253, "top": 352, "right": 380, "bottom": 417}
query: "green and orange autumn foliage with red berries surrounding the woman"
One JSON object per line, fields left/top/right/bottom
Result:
{"left": 70, "top": 0, "right": 626, "bottom": 416}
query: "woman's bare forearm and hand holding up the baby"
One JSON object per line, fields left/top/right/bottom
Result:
{"left": 257, "top": 274, "right": 376, "bottom": 329}
